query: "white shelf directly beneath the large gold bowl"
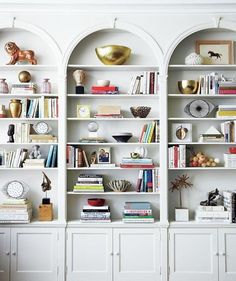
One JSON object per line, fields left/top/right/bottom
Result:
{"left": 68, "top": 64, "right": 158, "bottom": 71}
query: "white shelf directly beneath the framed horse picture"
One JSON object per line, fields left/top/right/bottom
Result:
{"left": 169, "top": 64, "right": 236, "bottom": 71}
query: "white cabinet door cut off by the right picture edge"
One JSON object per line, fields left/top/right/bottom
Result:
{"left": 218, "top": 228, "right": 236, "bottom": 281}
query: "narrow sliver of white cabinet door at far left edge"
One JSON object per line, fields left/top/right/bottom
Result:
{"left": 0, "top": 228, "right": 10, "bottom": 281}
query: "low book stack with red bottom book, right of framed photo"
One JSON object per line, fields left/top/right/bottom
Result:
{"left": 120, "top": 157, "right": 154, "bottom": 169}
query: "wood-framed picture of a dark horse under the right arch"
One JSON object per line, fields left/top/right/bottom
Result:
{"left": 196, "top": 40, "right": 234, "bottom": 64}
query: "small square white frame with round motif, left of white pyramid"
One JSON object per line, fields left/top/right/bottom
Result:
{"left": 171, "top": 123, "right": 192, "bottom": 142}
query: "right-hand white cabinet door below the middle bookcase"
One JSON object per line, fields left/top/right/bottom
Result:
{"left": 113, "top": 228, "right": 161, "bottom": 281}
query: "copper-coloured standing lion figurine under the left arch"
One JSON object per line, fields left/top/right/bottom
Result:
{"left": 5, "top": 42, "right": 37, "bottom": 64}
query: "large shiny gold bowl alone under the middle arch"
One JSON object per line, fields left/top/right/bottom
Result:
{"left": 95, "top": 45, "right": 131, "bottom": 65}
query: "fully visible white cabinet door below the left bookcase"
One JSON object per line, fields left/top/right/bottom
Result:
{"left": 11, "top": 228, "right": 58, "bottom": 281}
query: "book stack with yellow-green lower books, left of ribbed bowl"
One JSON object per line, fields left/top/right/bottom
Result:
{"left": 73, "top": 174, "right": 104, "bottom": 192}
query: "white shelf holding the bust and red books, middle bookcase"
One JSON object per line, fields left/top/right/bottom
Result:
{"left": 67, "top": 94, "right": 159, "bottom": 99}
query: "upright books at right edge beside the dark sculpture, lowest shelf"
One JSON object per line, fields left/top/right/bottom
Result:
{"left": 223, "top": 190, "right": 236, "bottom": 223}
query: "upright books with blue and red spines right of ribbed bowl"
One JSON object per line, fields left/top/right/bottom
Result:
{"left": 135, "top": 169, "right": 160, "bottom": 192}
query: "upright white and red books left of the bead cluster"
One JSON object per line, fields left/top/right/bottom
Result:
{"left": 168, "top": 144, "right": 186, "bottom": 168}
